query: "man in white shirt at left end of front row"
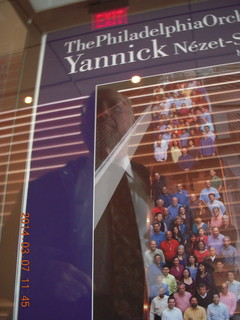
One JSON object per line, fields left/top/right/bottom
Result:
{"left": 150, "top": 287, "right": 168, "bottom": 320}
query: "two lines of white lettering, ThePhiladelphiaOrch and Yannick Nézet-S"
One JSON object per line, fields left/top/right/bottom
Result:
{"left": 64, "top": 9, "right": 240, "bottom": 74}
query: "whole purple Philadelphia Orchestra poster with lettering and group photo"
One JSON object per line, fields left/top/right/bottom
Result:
{"left": 18, "top": 1, "right": 240, "bottom": 320}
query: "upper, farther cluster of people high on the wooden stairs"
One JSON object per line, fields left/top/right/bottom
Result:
{"left": 152, "top": 82, "right": 216, "bottom": 166}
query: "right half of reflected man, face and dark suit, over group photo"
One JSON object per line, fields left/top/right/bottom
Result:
{"left": 93, "top": 89, "right": 150, "bottom": 320}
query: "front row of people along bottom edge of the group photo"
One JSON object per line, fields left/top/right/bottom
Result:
{"left": 150, "top": 284, "right": 235, "bottom": 320}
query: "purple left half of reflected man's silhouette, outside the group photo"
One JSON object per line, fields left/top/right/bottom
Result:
{"left": 19, "top": 92, "right": 95, "bottom": 320}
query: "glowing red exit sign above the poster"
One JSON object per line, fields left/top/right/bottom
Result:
{"left": 92, "top": 8, "right": 128, "bottom": 30}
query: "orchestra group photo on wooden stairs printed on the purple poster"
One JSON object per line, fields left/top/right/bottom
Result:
{"left": 93, "top": 64, "right": 240, "bottom": 319}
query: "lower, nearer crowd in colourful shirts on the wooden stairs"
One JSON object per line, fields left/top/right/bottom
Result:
{"left": 147, "top": 170, "right": 240, "bottom": 320}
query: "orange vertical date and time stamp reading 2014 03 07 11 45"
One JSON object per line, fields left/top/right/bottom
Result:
{"left": 20, "top": 213, "right": 30, "bottom": 308}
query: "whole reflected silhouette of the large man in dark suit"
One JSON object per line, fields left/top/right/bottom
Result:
{"left": 20, "top": 89, "right": 150, "bottom": 320}
